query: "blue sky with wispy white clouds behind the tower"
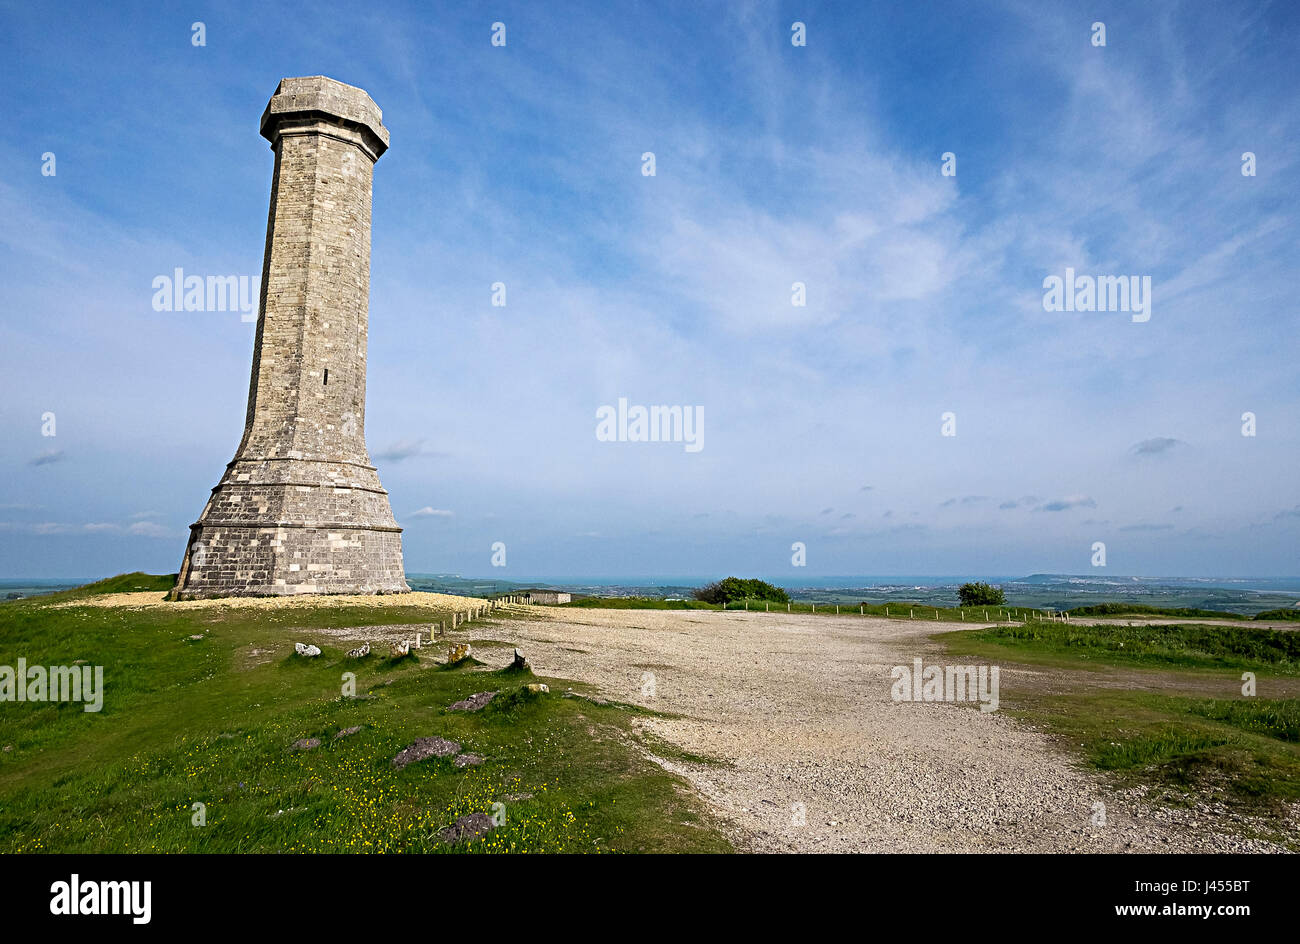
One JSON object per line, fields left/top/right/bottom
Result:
{"left": 0, "top": 1, "right": 1300, "bottom": 580}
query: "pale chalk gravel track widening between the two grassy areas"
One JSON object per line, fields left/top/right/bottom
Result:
{"left": 471, "top": 607, "right": 1284, "bottom": 853}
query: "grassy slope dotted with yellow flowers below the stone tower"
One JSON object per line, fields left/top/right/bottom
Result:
{"left": 0, "top": 575, "right": 731, "bottom": 853}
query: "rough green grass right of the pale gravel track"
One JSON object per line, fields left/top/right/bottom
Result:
{"left": 936, "top": 623, "right": 1300, "bottom": 846}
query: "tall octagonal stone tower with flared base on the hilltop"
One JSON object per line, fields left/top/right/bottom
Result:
{"left": 173, "top": 75, "right": 410, "bottom": 599}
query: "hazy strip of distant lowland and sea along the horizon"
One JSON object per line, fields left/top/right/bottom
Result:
{"left": 0, "top": 573, "right": 1300, "bottom": 615}
